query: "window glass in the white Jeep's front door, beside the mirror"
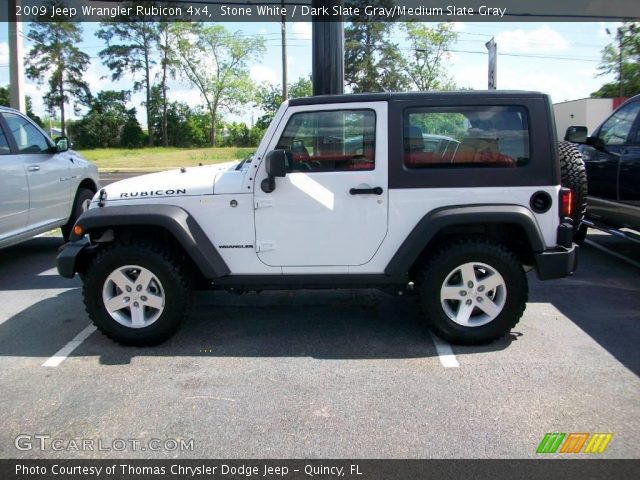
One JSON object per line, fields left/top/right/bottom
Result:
{"left": 276, "top": 110, "right": 376, "bottom": 172}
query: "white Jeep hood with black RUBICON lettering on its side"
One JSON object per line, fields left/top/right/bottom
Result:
{"left": 99, "top": 162, "right": 237, "bottom": 202}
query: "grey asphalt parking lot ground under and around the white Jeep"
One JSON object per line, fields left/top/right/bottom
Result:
{"left": 0, "top": 227, "right": 640, "bottom": 458}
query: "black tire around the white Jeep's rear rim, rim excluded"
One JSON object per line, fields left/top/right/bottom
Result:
{"left": 417, "top": 238, "right": 528, "bottom": 345}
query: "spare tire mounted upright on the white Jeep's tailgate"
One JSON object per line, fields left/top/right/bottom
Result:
{"left": 558, "top": 142, "right": 587, "bottom": 243}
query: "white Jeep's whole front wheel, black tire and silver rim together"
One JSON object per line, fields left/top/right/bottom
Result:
{"left": 83, "top": 243, "right": 191, "bottom": 346}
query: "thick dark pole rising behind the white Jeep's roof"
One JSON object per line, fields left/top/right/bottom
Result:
{"left": 311, "top": 0, "right": 344, "bottom": 95}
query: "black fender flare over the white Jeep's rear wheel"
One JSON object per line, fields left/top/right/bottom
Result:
{"left": 384, "top": 205, "right": 545, "bottom": 276}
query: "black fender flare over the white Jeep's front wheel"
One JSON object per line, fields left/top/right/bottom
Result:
{"left": 71, "top": 204, "right": 231, "bottom": 279}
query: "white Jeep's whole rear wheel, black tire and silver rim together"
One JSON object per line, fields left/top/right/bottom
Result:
{"left": 418, "top": 239, "right": 528, "bottom": 345}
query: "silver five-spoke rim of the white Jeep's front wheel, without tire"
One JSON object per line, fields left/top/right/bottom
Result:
{"left": 102, "top": 265, "right": 165, "bottom": 328}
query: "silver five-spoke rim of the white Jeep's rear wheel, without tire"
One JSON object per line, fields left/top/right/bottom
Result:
{"left": 440, "top": 262, "right": 507, "bottom": 327}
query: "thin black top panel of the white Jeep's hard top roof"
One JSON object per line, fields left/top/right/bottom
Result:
{"left": 289, "top": 90, "right": 547, "bottom": 106}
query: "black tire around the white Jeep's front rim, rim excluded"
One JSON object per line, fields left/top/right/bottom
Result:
{"left": 83, "top": 242, "right": 192, "bottom": 346}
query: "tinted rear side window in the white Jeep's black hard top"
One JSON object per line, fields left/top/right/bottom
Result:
{"left": 403, "top": 106, "right": 529, "bottom": 168}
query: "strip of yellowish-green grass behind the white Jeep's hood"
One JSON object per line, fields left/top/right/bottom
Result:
{"left": 79, "top": 147, "right": 255, "bottom": 172}
